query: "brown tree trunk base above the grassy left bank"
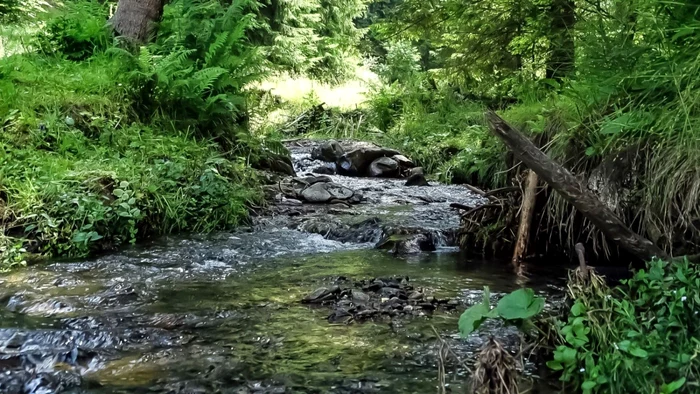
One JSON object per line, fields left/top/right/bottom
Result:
{"left": 110, "top": 0, "right": 165, "bottom": 43}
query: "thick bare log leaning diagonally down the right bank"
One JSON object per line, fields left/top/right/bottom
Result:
{"left": 486, "top": 111, "right": 668, "bottom": 261}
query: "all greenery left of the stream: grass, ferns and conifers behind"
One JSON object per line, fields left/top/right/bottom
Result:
{"left": 0, "top": 0, "right": 363, "bottom": 269}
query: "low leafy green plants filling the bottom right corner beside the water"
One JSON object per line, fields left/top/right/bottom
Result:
{"left": 547, "top": 261, "right": 700, "bottom": 394}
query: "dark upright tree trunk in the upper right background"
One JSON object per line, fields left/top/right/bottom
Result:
{"left": 547, "top": 0, "right": 576, "bottom": 80}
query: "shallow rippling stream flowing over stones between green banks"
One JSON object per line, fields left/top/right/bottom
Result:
{"left": 0, "top": 141, "right": 566, "bottom": 394}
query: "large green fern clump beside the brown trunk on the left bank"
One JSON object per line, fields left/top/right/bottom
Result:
{"left": 112, "top": 0, "right": 264, "bottom": 149}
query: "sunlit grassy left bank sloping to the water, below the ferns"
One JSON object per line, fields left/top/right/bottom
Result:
{"left": 0, "top": 54, "right": 261, "bottom": 270}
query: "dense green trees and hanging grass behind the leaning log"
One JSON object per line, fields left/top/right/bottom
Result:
{"left": 308, "top": 0, "right": 700, "bottom": 254}
